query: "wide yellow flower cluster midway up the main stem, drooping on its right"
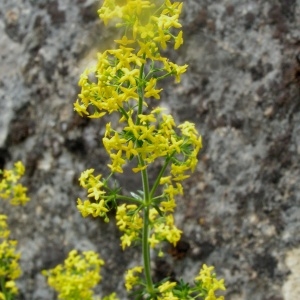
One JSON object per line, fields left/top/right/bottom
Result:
{"left": 103, "top": 108, "right": 202, "bottom": 175}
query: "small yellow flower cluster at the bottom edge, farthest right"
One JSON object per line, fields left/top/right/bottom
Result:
{"left": 195, "top": 264, "right": 226, "bottom": 300}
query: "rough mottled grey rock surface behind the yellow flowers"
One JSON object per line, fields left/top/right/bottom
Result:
{"left": 0, "top": 0, "right": 300, "bottom": 300}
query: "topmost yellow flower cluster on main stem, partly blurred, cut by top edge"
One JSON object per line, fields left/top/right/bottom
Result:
{"left": 98, "top": 0, "right": 183, "bottom": 51}
